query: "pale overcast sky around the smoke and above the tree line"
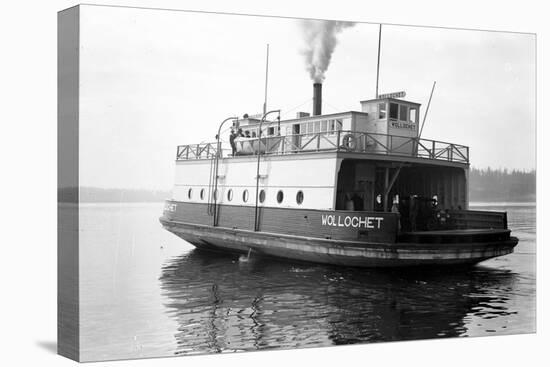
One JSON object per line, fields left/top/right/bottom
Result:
{"left": 80, "top": 6, "right": 535, "bottom": 189}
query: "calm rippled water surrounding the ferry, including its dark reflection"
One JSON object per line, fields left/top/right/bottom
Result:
{"left": 75, "top": 203, "right": 535, "bottom": 360}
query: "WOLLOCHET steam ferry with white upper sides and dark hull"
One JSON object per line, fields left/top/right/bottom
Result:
{"left": 160, "top": 83, "right": 518, "bottom": 267}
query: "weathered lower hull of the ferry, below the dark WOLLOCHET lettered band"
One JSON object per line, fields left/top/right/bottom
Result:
{"left": 160, "top": 217, "right": 518, "bottom": 267}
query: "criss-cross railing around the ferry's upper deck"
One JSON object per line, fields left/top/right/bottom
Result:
{"left": 176, "top": 130, "right": 469, "bottom": 163}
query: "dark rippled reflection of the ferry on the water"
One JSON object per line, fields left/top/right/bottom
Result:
{"left": 160, "top": 250, "right": 517, "bottom": 354}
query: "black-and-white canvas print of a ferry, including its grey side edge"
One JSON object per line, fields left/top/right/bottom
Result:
{"left": 58, "top": 5, "right": 536, "bottom": 361}
